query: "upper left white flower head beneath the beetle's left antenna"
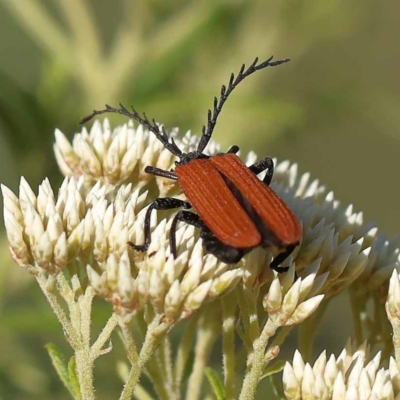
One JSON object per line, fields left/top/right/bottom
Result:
{"left": 54, "top": 118, "right": 218, "bottom": 197}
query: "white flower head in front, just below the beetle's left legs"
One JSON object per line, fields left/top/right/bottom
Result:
{"left": 87, "top": 220, "right": 243, "bottom": 322}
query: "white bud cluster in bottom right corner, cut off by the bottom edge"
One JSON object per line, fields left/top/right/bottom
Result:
{"left": 283, "top": 343, "right": 400, "bottom": 400}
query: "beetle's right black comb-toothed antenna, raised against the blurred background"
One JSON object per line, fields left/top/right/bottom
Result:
{"left": 197, "top": 56, "right": 290, "bottom": 153}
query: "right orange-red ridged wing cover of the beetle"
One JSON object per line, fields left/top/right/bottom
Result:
{"left": 210, "top": 154, "right": 302, "bottom": 245}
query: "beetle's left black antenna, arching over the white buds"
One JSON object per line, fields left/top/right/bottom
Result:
{"left": 79, "top": 103, "right": 182, "bottom": 157}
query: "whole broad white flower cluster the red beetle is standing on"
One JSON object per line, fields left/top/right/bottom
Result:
{"left": 2, "top": 119, "right": 398, "bottom": 318}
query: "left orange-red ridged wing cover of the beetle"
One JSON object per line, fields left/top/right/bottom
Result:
{"left": 175, "top": 158, "right": 261, "bottom": 248}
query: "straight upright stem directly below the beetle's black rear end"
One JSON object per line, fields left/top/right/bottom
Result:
{"left": 222, "top": 293, "right": 237, "bottom": 400}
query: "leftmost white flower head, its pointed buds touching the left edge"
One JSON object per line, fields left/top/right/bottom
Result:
{"left": 1, "top": 178, "right": 147, "bottom": 274}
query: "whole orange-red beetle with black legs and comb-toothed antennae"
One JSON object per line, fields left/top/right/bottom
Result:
{"left": 80, "top": 57, "right": 302, "bottom": 272}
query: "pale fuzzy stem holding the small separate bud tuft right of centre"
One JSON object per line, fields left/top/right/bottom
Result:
{"left": 239, "top": 319, "right": 279, "bottom": 400}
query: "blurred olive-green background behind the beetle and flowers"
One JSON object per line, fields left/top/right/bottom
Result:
{"left": 0, "top": 0, "right": 400, "bottom": 399}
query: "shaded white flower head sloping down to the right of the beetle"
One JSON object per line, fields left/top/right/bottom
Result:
{"left": 247, "top": 153, "right": 399, "bottom": 297}
